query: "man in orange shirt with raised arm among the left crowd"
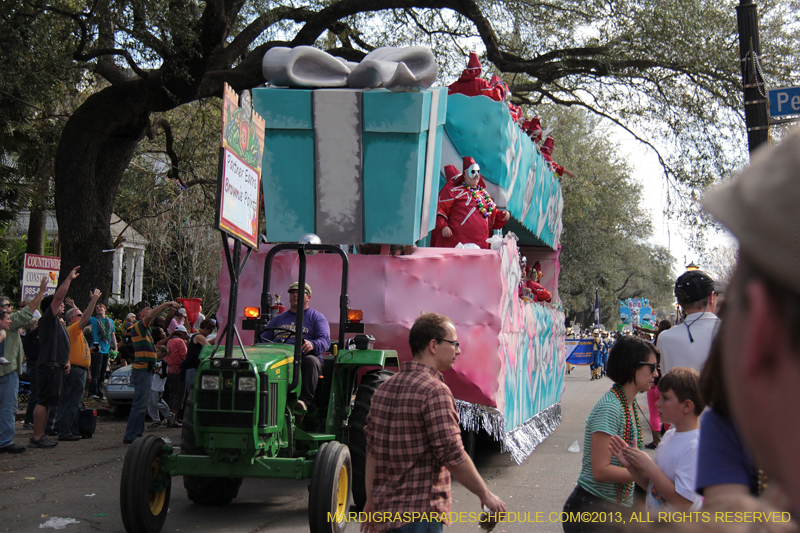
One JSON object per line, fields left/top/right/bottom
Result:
{"left": 55, "top": 289, "right": 101, "bottom": 441}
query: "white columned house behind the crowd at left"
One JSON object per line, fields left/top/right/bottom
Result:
{"left": 8, "top": 211, "right": 147, "bottom": 304}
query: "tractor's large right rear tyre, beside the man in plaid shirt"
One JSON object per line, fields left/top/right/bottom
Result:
{"left": 348, "top": 368, "right": 394, "bottom": 512}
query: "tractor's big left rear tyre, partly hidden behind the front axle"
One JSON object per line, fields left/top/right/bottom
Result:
{"left": 181, "top": 398, "right": 242, "bottom": 505}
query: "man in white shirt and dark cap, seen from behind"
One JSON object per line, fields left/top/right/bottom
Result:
{"left": 658, "top": 270, "right": 719, "bottom": 374}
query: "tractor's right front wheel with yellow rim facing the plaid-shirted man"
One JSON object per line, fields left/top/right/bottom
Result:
{"left": 308, "top": 441, "right": 353, "bottom": 533}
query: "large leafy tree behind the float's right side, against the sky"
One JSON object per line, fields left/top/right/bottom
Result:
{"left": 538, "top": 106, "right": 674, "bottom": 327}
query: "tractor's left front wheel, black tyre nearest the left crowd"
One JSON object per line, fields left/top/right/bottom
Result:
{"left": 119, "top": 435, "right": 172, "bottom": 533}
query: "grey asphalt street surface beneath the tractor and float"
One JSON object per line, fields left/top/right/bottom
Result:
{"left": 0, "top": 367, "right": 650, "bottom": 533}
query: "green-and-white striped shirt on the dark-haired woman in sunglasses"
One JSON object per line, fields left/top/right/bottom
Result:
{"left": 578, "top": 391, "right": 638, "bottom": 507}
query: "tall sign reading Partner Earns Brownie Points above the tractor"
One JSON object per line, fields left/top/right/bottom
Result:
{"left": 217, "top": 83, "right": 264, "bottom": 248}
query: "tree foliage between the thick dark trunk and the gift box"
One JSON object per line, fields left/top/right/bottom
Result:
{"left": 114, "top": 99, "right": 222, "bottom": 312}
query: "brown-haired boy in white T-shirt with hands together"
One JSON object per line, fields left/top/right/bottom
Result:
{"left": 609, "top": 367, "right": 705, "bottom": 512}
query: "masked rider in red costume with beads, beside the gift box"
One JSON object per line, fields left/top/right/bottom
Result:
{"left": 431, "top": 157, "right": 509, "bottom": 249}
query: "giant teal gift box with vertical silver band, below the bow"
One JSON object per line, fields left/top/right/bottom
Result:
{"left": 252, "top": 88, "right": 447, "bottom": 244}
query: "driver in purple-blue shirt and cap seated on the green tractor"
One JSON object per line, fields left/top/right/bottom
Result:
{"left": 261, "top": 282, "right": 331, "bottom": 411}
